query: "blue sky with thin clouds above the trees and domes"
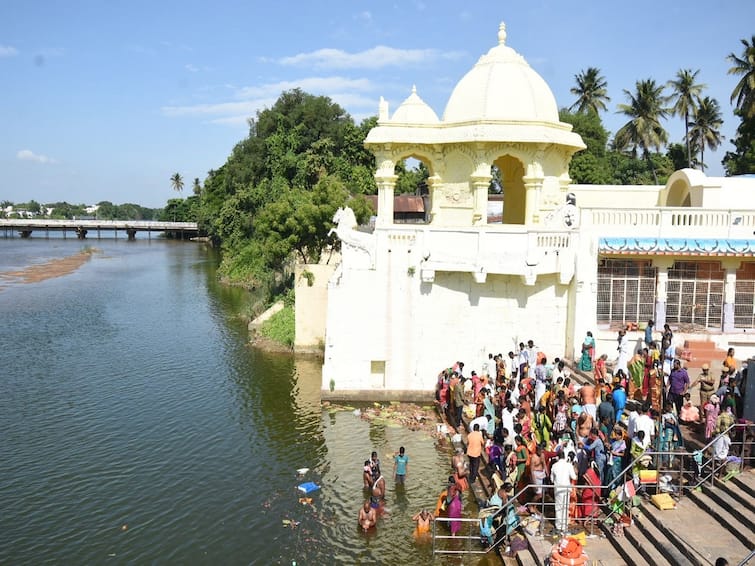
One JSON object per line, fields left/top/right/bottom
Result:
{"left": 0, "top": 0, "right": 755, "bottom": 207}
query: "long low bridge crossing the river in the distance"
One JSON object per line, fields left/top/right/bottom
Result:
{"left": 0, "top": 218, "right": 199, "bottom": 240}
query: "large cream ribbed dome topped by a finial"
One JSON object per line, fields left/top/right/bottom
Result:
{"left": 443, "top": 23, "right": 559, "bottom": 123}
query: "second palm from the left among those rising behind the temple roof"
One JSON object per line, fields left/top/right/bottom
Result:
{"left": 614, "top": 79, "right": 668, "bottom": 185}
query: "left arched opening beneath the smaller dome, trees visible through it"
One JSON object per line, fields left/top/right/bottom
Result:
{"left": 393, "top": 155, "right": 432, "bottom": 224}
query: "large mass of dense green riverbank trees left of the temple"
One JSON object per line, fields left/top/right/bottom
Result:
{"left": 197, "top": 89, "right": 377, "bottom": 296}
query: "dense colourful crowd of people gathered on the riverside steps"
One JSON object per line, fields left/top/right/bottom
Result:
{"left": 436, "top": 321, "right": 746, "bottom": 534}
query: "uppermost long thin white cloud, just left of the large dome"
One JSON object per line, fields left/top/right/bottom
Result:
{"left": 278, "top": 45, "right": 459, "bottom": 69}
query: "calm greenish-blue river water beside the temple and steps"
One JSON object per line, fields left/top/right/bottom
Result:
{"left": 0, "top": 237, "right": 496, "bottom": 565}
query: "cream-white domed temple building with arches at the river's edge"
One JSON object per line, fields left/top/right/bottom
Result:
{"left": 304, "top": 24, "right": 755, "bottom": 399}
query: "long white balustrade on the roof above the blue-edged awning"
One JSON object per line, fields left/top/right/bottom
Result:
{"left": 580, "top": 207, "right": 755, "bottom": 239}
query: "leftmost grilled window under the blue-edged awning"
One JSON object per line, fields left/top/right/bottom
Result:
{"left": 597, "top": 258, "right": 656, "bottom": 325}
